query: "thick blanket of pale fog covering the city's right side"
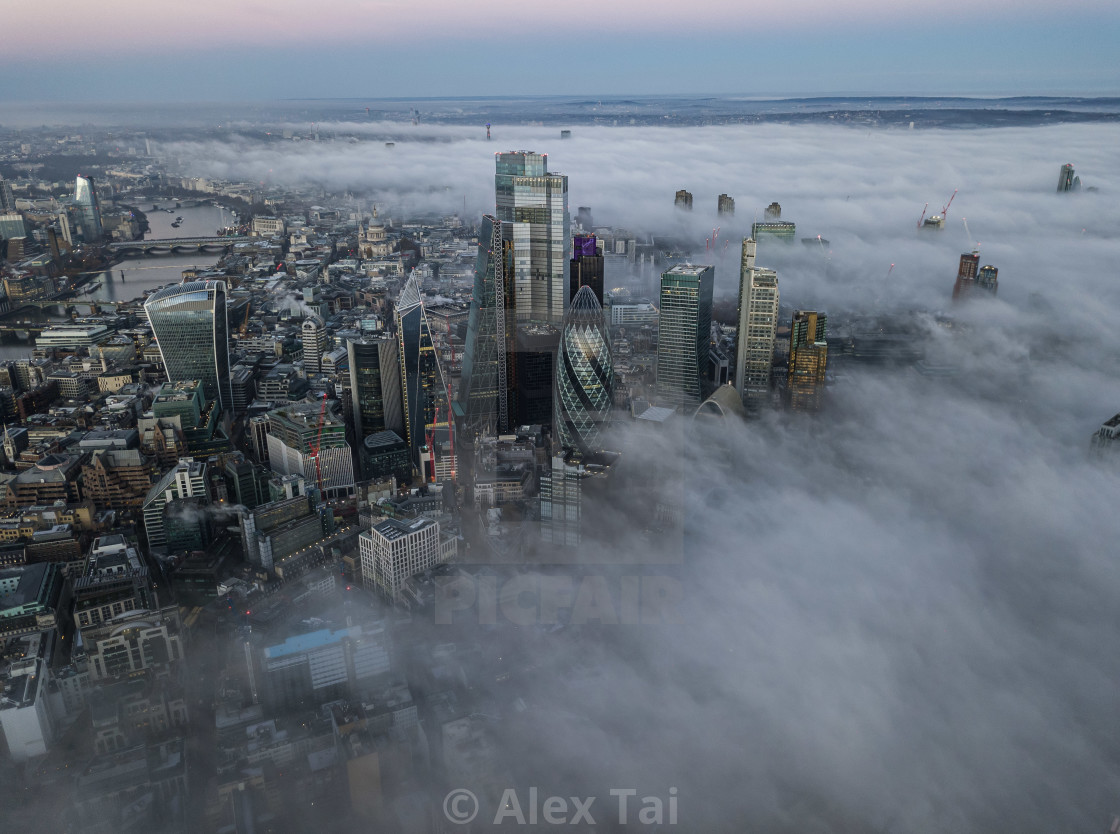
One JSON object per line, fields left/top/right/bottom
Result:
{"left": 2, "top": 115, "right": 1120, "bottom": 834}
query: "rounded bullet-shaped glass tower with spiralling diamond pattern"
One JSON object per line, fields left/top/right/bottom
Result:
{"left": 552, "top": 287, "right": 614, "bottom": 452}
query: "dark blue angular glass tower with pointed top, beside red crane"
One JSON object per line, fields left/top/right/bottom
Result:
{"left": 396, "top": 275, "right": 449, "bottom": 466}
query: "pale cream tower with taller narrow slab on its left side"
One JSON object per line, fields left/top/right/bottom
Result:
{"left": 735, "top": 237, "right": 778, "bottom": 402}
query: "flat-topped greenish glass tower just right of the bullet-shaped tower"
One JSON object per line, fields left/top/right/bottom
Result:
{"left": 657, "top": 263, "right": 716, "bottom": 410}
